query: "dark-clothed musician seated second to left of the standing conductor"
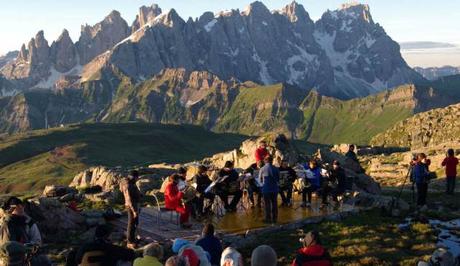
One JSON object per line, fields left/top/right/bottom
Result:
{"left": 216, "top": 161, "right": 243, "bottom": 212}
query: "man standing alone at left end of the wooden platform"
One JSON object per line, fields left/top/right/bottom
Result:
{"left": 120, "top": 170, "right": 142, "bottom": 248}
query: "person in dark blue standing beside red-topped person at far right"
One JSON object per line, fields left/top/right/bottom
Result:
{"left": 411, "top": 153, "right": 429, "bottom": 207}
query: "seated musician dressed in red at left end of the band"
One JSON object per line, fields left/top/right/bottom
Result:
{"left": 165, "top": 174, "right": 190, "bottom": 228}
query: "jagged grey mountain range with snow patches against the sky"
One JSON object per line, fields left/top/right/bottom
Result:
{"left": 1, "top": 2, "right": 421, "bottom": 99}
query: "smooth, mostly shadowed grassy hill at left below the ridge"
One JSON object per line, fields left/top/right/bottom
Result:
{"left": 0, "top": 123, "right": 246, "bottom": 193}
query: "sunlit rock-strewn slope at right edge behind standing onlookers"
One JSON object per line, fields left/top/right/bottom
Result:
{"left": 371, "top": 104, "right": 460, "bottom": 149}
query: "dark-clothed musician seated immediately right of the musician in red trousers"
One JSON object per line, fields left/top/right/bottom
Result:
{"left": 193, "top": 165, "right": 215, "bottom": 215}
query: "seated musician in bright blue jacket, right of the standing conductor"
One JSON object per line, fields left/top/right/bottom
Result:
{"left": 301, "top": 160, "right": 327, "bottom": 207}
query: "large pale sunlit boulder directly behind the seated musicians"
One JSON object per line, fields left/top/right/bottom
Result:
{"left": 203, "top": 134, "right": 299, "bottom": 169}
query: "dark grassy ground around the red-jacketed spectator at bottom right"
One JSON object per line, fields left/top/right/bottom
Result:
{"left": 242, "top": 211, "right": 436, "bottom": 265}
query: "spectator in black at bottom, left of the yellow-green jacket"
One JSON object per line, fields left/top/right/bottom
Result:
{"left": 75, "top": 225, "right": 135, "bottom": 266}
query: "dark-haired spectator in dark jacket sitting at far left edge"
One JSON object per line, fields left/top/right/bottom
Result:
{"left": 0, "top": 197, "right": 42, "bottom": 246}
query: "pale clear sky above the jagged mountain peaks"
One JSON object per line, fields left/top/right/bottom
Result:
{"left": 0, "top": 0, "right": 460, "bottom": 54}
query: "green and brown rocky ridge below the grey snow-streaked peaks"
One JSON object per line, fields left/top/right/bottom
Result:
{"left": 0, "top": 68, "right": 450, "bottom": 143}
